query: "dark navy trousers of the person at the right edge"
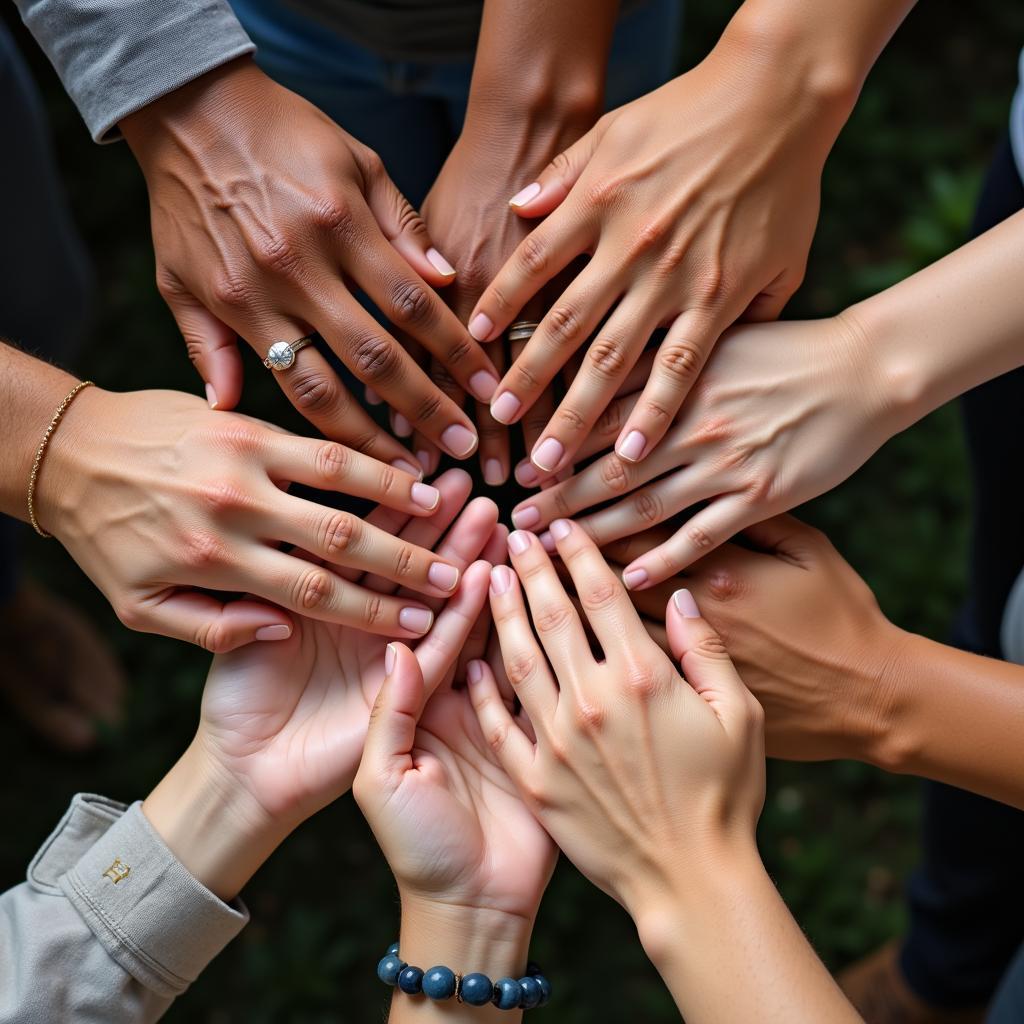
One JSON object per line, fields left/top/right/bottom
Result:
{"left": 902, "top": 138, "right": 1024, "bottom": 1007}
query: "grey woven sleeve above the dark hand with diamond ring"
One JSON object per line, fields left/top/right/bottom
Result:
{"left": 14, "top": 0, "right": 255, "bottom": 142}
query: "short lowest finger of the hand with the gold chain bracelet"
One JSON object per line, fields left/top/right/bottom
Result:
{"left": 132, "top": 590, "right": 292, "bottom": 654}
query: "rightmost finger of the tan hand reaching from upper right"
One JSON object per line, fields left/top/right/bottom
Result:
{"left": 615, "top": 309, "right": 729, "bottom": 462}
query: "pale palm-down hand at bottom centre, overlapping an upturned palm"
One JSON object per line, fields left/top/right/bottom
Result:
{"left": 470, "top": 520, "right": 764, "bottom": 932}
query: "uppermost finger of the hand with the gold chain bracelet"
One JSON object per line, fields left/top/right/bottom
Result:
{"left": 265, "top": 434, "right": 440, "bottom": 516}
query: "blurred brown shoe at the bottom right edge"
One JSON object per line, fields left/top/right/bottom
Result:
{"left": 836, "top": 940, "right": 985, "bottom": 1024}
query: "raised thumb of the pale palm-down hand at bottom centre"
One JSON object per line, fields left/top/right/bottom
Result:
{"left": 665, "top": 590, "right": 754, "bottom": 731}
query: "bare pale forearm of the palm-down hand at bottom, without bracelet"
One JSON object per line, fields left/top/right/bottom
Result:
{"left": 631, "top": 841, "right": 860, "bottom": 1024}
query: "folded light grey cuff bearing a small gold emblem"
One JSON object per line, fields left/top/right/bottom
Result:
{"left": 58, "top": 803, "right": 249, "bottom": 997}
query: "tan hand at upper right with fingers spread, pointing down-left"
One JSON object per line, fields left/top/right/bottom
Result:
{"left": 470, "top": 32, "right": 841, "bottom": 474}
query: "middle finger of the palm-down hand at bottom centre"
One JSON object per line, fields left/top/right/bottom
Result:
{"left": 501, "top": 529, "right": 590, "bottom": 685}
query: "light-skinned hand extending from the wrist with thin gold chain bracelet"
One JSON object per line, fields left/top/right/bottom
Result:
{"left": 37, "top": 388, "right": 473, "bottom": 651}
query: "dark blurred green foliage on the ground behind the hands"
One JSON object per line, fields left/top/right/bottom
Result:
{"left": 0, "top": 0, "right": 1024, "bottom": 1024}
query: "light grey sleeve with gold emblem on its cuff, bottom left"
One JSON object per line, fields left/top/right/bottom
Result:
{"left": 0, "top": 794, "right": 249, "bottom": 1024}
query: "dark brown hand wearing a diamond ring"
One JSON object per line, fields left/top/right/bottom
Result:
{"left": 121, "top": 59, "right": 497, "bottom": 462}
